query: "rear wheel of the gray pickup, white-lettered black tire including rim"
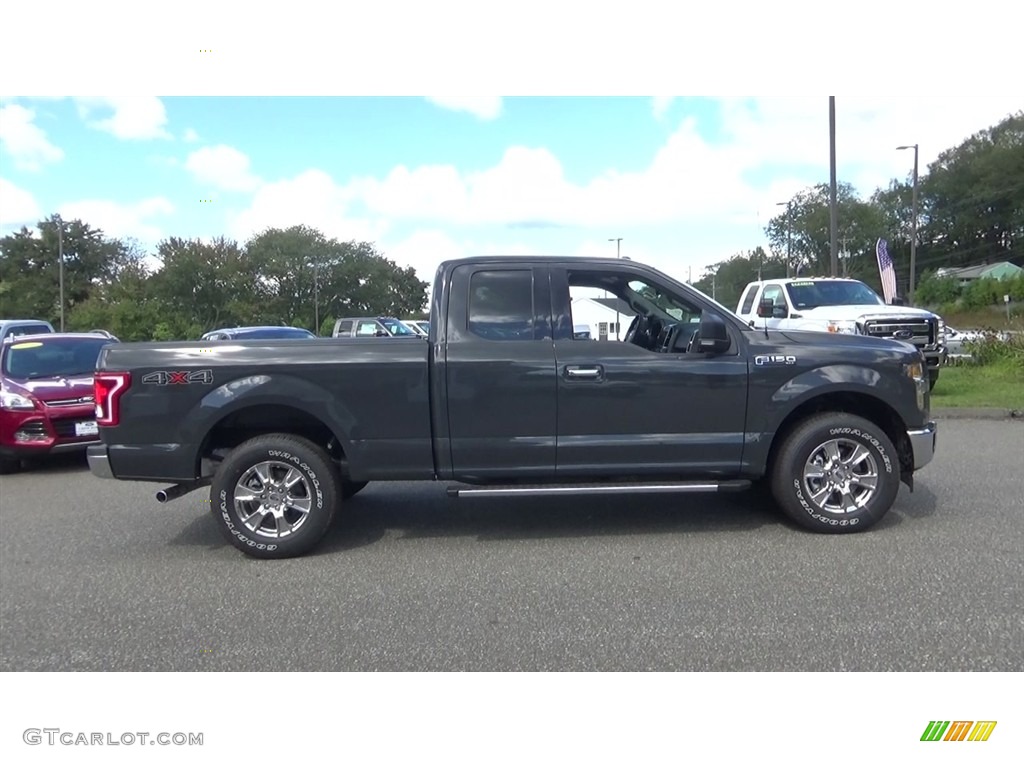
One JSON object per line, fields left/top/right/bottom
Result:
{"left": 210, "top": 434, "right": 341, "bottom": 558}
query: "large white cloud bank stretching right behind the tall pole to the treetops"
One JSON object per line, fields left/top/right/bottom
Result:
{"left": 348, "top": 98, "right": 1015, "bottom": 240}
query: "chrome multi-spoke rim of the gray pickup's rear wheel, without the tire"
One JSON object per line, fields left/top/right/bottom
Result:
{"left": 234, "top": 461, "right": 312, "bottom": 539}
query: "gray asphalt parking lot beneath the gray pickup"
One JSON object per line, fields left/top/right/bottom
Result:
{"left": 0, "top": 420, "right": 1024, "bottom": 672}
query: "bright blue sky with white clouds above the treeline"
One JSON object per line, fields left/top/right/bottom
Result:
{"left": 0, "top": 3, "right": 1024, "bottom": 290}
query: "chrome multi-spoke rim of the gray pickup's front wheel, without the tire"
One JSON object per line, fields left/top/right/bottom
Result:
{"left": 804, "top": 437, "right": 879, "bottom": 515}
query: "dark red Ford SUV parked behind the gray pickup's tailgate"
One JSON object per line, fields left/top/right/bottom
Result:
{"left": 0, "top": 333, "right": 117, "bottom": 472}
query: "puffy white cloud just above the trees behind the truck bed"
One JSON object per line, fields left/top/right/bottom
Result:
{"left": 229, "top": 169, "right": 387, "bottom": 242}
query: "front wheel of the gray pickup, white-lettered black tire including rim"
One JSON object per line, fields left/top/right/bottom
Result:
{"left": 771, "top": 413, "right": 899, "bottom": 534}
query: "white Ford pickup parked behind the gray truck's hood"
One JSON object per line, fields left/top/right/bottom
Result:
{"left": 736, "top": 278, "right": 946, "bottom": 387}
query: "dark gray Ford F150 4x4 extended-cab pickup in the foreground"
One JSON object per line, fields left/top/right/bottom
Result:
{"left": 88, "top": 257, "right": 936, "bottom": 558}
